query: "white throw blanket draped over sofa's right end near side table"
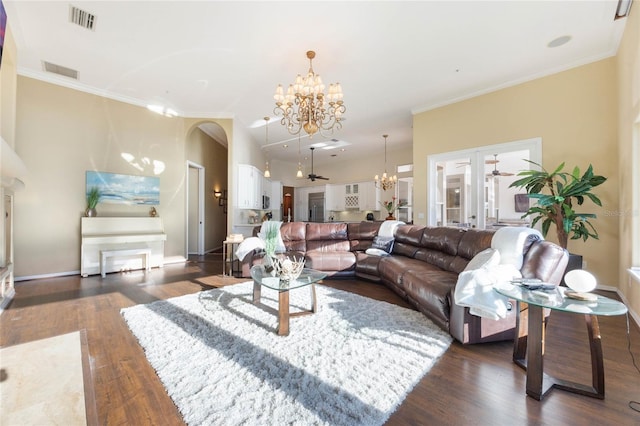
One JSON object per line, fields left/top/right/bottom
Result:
{"left": 454, "top": 227, "right": 542, "bottom": 320}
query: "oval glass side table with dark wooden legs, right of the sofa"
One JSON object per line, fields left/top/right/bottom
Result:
{"left": 494, "top": 284, "right": 627, "bottom": 401}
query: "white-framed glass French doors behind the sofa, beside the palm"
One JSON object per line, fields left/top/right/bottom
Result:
{"left": 427, "top": 138, "right": 542, "bottom": 229}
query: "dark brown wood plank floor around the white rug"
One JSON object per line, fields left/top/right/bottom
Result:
{"left": 0, "top": 255, "right": 640, "bottom": 425}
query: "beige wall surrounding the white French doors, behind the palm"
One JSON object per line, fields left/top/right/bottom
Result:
{"left": 413, "top": 58, "right": 619, "bottom": 286}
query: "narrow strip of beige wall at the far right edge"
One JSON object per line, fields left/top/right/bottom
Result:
{"left": 616, "top": 5, "right": 640, "bottom": 313}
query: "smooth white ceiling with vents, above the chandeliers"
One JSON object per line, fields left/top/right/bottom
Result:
{"left": 3, "top": 0, "right": 626, "bottom": 164}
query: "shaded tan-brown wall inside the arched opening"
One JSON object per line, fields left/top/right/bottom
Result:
{"left": 187, "top": 127, "right": 227, "bottom": 252}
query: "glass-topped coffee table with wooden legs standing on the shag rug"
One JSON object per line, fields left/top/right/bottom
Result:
{"left": 251, "top": 265, "right": 327, "bottom": 336}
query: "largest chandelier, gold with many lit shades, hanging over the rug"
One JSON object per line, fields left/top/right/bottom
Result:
{"left": 273, "top": 50, "right": 346, "bottom": 138}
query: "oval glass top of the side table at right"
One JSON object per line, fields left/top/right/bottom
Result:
{"left": 494, "top": 283, "right": 627, "bottom": 316}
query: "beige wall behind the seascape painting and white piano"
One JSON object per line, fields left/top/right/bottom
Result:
{"left": 14, "top": 77, "right": 186, "bottom": 277}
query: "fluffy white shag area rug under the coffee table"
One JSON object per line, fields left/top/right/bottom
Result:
{"left": 122, "top": 282, "right": 451, "bottom": 426}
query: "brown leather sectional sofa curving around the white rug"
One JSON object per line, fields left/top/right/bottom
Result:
{"left": 242, "top": 222, "right": 568, "bottom": 343}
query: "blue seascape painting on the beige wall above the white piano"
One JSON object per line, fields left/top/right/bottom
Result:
{"left": 86, "top": 171, "right": 160, "bottom": 206}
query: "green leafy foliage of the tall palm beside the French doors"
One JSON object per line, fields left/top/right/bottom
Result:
{"left": 509, "top": 160, "right": 607, "bottom": 249}
